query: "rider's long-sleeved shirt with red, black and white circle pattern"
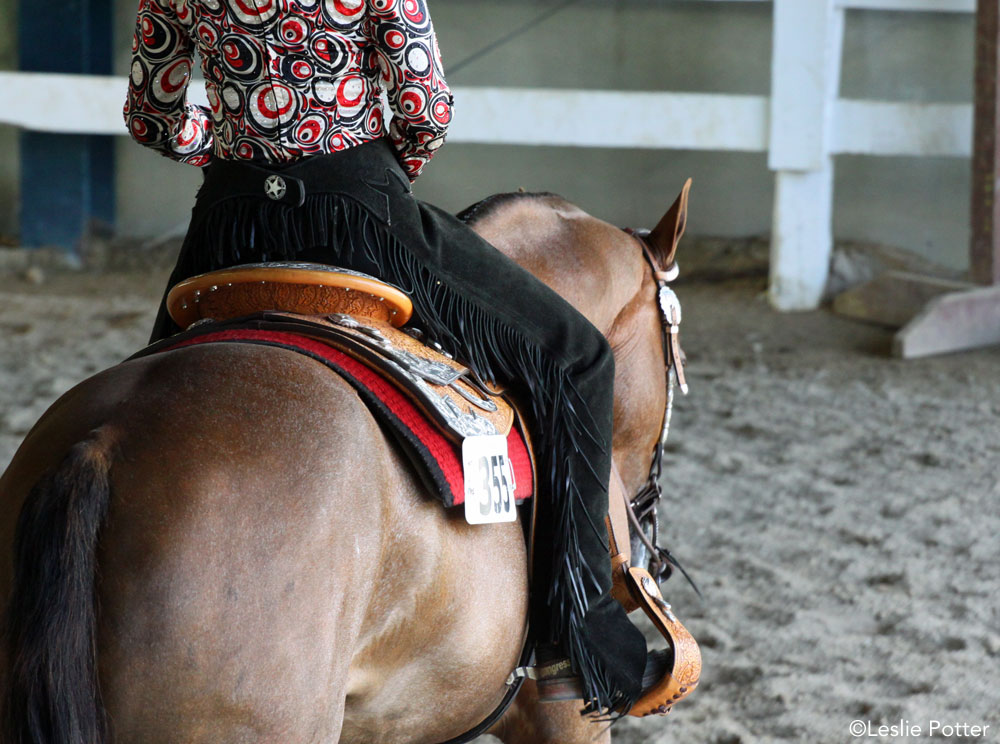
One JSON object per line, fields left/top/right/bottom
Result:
{"left": 125, "top": 0, "right": 453, "bottom": 180}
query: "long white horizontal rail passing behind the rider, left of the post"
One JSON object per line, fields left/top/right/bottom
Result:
{"left": 0, "top": 72, "right": 768, "bottom": 152}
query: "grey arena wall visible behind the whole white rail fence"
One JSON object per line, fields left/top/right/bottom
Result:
{"left": 0, "top": 0, "right": 974, "bottom": 268}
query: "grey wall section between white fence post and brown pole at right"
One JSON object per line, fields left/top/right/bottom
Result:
{"left": 834, "top": 6, "right": 975, "bottom": 269}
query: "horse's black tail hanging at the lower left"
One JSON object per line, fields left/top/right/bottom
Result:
{"left": 2, "top": 438, "right": 111, "bottom": 744}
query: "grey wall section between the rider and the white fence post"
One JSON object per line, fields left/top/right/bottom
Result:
{"left": 418, "top": 0, "right": 773, "bottom": 250}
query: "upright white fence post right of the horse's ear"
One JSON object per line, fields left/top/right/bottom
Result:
{"left": 768, "top": 0, "right": 844, "bottom": 310}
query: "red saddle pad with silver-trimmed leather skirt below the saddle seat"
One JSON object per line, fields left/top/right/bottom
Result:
{"left": 141, "top": 312, "right": 535, "bottom": 507}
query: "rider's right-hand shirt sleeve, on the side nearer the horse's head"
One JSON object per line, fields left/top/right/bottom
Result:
{"left": 369, "top": 0, "right": 454, "bottom": 181}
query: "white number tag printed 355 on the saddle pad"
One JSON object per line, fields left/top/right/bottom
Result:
{"left": 462, "top": 434, "right": 517, "bottom": 524}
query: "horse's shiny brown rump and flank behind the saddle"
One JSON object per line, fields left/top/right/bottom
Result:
{"left": 3, "top": 344, "right": 525, "bottom": 742}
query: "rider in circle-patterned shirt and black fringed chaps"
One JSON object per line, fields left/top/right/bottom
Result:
{"left": 125, "top": 0, "right": 646, "bottom": 712}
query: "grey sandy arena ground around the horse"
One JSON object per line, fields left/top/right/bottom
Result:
{"left": 0, "top": 253, "right": 1000, "bottom": 744}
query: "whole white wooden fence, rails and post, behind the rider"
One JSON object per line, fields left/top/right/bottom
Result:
{"left": 0, "top": 0, "right": 975, "bottom": 310}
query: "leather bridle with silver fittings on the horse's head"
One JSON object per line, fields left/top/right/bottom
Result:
{"left": 625, "top": 228, "right": 698, "bottom": 591}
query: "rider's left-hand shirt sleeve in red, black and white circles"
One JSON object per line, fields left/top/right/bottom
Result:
{"left": 124, "top": 0, "right": 213, "bottom": 166}
